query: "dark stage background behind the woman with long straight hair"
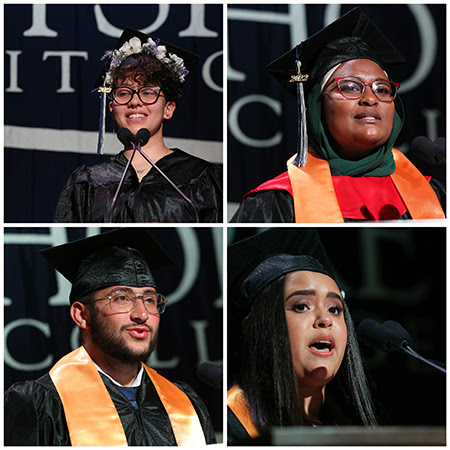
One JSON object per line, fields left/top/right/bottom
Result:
{"left": 228, "top": 228, "right": 446, "bottom": 426}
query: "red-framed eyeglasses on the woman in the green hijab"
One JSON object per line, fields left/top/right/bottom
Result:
{"left": 334, "top": 77, "right": 400, "bottom": 103}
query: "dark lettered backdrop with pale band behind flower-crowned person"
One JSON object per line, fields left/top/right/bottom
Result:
{"left": 4, "top": 4, "right": 223, "bottom": 223}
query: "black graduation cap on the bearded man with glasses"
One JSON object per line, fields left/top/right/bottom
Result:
{"left": 40, "top": 227, "right": 174, "bottom": 304}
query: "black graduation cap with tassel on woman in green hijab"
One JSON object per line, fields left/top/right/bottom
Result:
{"left": 266, "top": 7, "right": 406, "bottom": 166}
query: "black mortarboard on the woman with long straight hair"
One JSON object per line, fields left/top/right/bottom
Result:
{"left": 228, "top": 228, "right": 335, "bottom": 312}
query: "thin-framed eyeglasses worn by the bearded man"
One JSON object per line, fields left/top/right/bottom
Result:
{"left": 85, "top": 290, "right": 167, "bottom": 316}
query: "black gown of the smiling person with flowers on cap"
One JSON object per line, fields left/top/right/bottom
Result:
{"left": 54, "top": 149, "right": 222, "bottom": 223}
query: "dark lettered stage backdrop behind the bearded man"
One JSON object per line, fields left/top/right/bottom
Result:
{"left": 4, "top": 227, "right": 223, "bottom": 432}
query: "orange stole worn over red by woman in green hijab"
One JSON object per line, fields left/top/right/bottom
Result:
{"left": 287, "top": 148, "right": 445, "bottom": 223}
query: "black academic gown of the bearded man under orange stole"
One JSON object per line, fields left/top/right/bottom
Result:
{"left": 4, "top": 373, "right": 216, "bottom": 446}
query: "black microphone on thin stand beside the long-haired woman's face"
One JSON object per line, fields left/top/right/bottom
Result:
{"left": 356, "top": 319, "right": 447, "bottom": 373}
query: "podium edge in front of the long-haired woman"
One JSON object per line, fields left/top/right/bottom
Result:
{"left": 270, "top": 426, "right": 446, "bottom": 446}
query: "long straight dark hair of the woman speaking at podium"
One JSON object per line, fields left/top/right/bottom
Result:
{"left": 236, "top": 276, "right": 377, "bottom": 432}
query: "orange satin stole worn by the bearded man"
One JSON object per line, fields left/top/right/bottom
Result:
{"left": 50, "top": 347, "right": 205, "bottom": 446}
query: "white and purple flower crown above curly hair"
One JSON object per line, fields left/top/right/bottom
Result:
{"left": 102, "top": 37, "right": 189, "bottom": 86}
